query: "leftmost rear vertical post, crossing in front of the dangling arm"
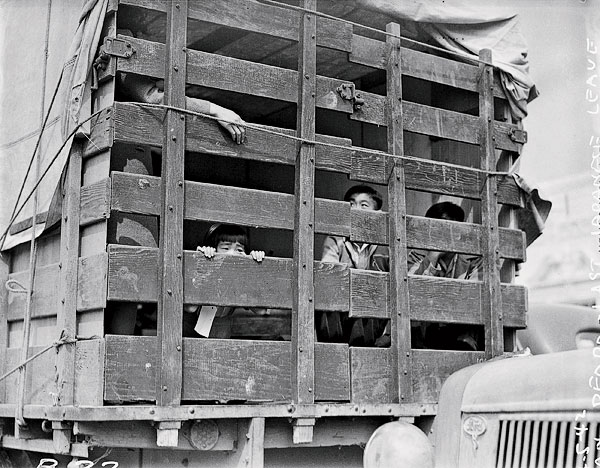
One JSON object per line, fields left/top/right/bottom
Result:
{"left": 156, "top": 0, "right": 188, "bottom": 408}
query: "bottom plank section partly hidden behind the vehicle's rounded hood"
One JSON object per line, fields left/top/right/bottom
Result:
{"left": 412, "top": 349, "right": 484, "bottom": 403}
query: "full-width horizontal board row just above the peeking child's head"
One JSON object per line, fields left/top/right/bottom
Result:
{"left": 112, "top": 172, "right": 525, "bottom": 260}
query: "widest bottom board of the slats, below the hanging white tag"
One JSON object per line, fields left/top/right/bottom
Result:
{"left": 104, "top": 335, "right": 349, "bottom": 402}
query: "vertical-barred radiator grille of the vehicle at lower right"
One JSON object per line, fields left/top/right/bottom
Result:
{"left": 496, "top": 420, "right": 600, "bottom": 468}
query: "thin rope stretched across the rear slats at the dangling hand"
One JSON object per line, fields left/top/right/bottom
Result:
{"left": 135, "top": 102, "right": 513, "bottom": 177}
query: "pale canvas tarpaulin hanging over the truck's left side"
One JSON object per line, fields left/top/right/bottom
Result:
{"left": 0, "top": 0, "right": 107, "bottom": 250}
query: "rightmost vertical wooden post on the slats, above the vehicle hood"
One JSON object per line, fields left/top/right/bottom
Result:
{"left": 479, "top": 49, "right": 504, "bottom": 358}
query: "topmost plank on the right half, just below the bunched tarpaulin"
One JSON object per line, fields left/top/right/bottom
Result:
{"left": 348, "top": 34, "right": 506, "bottom": 99}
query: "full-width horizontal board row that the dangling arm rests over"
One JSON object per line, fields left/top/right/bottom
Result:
{"left": 102, "top": 103, "right": 521, "bottom": 206}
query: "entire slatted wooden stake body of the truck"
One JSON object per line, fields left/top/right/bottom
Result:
{"left": 3, "top": 0, "right": 526, "bottom": 458}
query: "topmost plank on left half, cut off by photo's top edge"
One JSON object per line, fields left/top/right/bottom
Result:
{"left": 119, "top": 0, "right": 352, "bottom": 52}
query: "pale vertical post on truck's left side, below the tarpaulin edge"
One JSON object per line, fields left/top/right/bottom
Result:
{"left": 52, "top": 140, "right": 83, "bottom": 453}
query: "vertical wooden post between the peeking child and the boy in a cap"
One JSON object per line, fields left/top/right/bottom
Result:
{"left": 292, "top": 0, "right": 317, "bottom": 443}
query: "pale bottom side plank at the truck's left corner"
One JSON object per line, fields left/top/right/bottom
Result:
{"left": 73, "top": 339, "right": 104, "bottom": 406}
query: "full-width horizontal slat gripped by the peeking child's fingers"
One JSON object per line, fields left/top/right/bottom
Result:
{"left": 108, "top": 245, "right": 526, "bottom": 327}
